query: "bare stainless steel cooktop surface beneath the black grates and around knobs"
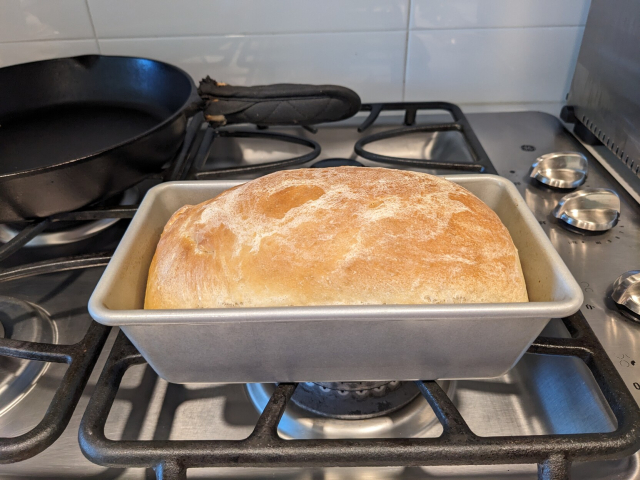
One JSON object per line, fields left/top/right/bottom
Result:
{"left": 0, "top": 112, "right": 640, "bottom": 480}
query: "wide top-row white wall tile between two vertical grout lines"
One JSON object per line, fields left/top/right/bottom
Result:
{"left": 89, "top": 0, "right": 409, "bottom": 38}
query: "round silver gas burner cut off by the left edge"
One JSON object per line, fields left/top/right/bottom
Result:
{"left": 0, "top": 296, "right": 58, "bottom": 415}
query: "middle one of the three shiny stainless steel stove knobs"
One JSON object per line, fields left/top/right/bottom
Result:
{"left": 553, "top": 188, "right": 620, "bottom": 232}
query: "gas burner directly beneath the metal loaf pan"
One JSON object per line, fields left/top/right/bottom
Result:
{"left": 247, "top": 381, "right": 455, "bottom": 439}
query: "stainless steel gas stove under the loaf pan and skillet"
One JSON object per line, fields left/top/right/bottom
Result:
{"left": 0, "top": 107, "right": 640, "bottom": 480}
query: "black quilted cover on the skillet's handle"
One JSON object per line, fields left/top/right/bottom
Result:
{"left": 198, "top": 77, "right": 360, "bottom": 127}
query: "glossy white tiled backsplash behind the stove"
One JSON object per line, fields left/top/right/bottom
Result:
{"left": 0, "top": 0, "right": 590, "bottom": 114}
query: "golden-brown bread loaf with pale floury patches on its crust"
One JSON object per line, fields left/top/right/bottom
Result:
{"left": 145, "top": 167, "right": 528, "bottom": 309}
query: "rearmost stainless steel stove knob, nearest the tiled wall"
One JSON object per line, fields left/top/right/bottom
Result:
{"left": 530, "top": 152, "right": 589, "bottom": 188}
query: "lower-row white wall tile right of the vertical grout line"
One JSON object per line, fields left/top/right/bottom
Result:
{"left": 405, "top": 27, "right": 583, "bottom": 104}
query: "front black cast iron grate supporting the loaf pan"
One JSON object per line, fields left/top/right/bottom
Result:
{"left": 79, "top": 312, "right": 640, "bottom": 480}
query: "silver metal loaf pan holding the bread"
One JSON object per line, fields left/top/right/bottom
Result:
{"left": 89, "top": 175, "right": 583, "bottom": 383}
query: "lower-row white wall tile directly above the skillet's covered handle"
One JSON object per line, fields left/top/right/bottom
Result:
{"left": 99, "top": 32, "right": 406, "bottom": 101}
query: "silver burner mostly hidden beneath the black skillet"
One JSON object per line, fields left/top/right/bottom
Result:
{"left": 0, "top": 188, "right": 138, "bottom": 247}
